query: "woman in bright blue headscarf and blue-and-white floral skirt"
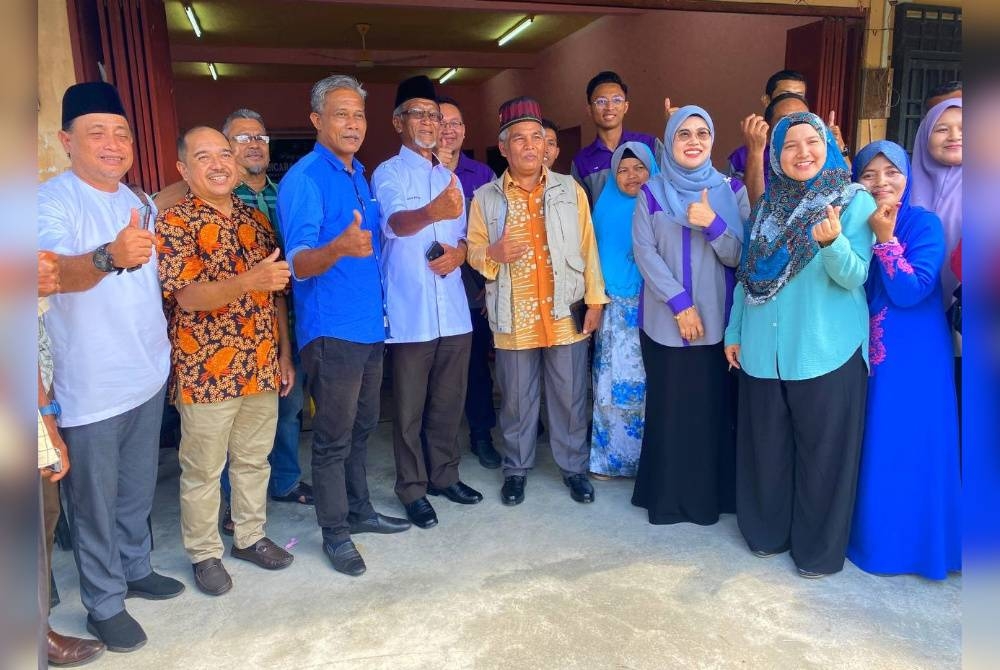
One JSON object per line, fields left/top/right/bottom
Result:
{"left": 590, "top": 142, "right": 659, "bottom": 479}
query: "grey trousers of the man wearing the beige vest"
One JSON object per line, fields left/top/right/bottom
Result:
{"left": 496, "top": 340, "right": 590, "bottom": 477}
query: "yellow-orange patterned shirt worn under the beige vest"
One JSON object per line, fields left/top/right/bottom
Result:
{"left": 468, "top": 172, "right": 608, "bottom": 350}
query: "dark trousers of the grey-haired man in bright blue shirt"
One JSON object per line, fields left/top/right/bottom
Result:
{"left": 302, "top": 337, "right": 385, "bottom": 542}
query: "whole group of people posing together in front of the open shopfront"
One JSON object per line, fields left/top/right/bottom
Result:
{"left": 39, "top": 71, "right": 961, "bottom": 664}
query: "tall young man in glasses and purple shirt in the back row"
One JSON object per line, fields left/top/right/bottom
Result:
{"left": 570, "top": 70, "right": 663, "bottom": 208}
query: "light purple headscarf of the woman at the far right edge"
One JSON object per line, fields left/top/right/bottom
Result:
{"left": 910, "top": 98, "right": 962, "bottom": 299}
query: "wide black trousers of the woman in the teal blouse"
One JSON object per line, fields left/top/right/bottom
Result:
{"left": 737, "top": 350, "right": 868, "bottom": 574}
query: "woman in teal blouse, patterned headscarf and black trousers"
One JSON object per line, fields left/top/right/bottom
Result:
{"left": 725, "top": 112, "right": 875, "bottom": 578}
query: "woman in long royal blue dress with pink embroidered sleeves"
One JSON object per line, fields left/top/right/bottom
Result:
{"left": 847, "top": 141, "right": 961, "bottom": 579}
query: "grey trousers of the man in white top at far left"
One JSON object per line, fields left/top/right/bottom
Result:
{"left": 62, "top": 386, "right": 166, "bottom": 621}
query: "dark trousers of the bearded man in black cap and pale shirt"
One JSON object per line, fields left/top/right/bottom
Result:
{"left": 389, "top": 333, "right": 472, "bottom": 505}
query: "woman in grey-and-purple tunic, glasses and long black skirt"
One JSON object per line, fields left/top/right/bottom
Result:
{"left": 632, "top": 105, "right": 750, "bottom": 525}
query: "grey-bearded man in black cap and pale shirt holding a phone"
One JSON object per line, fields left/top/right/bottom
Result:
{"left": 372, "top": 76, "right": 483, "bottom": 528}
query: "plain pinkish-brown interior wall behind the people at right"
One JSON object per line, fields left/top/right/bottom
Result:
{"left": 483, "top": 11, "right": 815, "bottom": 168}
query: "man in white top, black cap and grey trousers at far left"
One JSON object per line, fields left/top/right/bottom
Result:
{"left": 38, "top": 82, "right": 184, "bottom": 652}
